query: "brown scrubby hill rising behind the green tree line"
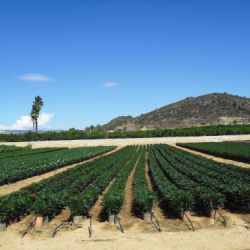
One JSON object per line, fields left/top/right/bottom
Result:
{"left": 96, "top": 93, "right": 250, "bottom": 131}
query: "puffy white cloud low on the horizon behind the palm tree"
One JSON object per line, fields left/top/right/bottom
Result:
{"left": 0, "top": 113, "right": 54, "bottom": 130}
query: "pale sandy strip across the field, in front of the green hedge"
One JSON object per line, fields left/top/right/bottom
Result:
{"left": 0, "top": 135, "right": 250, "bottom": 148}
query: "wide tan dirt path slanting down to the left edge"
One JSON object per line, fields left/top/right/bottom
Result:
{"left": 0, "top": 147, "right": 122, "bottom": 196}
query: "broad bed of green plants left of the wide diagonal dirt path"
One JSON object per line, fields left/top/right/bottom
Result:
{"left": 0, "top": 146, "right": 114, "bottom": 185}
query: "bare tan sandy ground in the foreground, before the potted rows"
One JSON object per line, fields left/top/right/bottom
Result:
{"left": 0, "top": 212, "right": 250, "bottom": 250}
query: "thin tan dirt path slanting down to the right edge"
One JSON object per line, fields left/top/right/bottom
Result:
{"left": 171, "top": 144, "right": 250, "bottom": 168}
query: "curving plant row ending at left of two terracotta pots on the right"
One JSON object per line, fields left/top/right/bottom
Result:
{"left": 148, "top": 146, "right": 195, "bottom": 215}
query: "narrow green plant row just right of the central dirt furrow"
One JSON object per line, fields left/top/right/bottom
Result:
{"left": 133, "top": 146, "right": 156, "bottom": 217}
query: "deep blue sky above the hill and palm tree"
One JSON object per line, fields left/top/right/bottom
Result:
{"left": 0, "top": 0, "right": 250, "bottom": 129}
